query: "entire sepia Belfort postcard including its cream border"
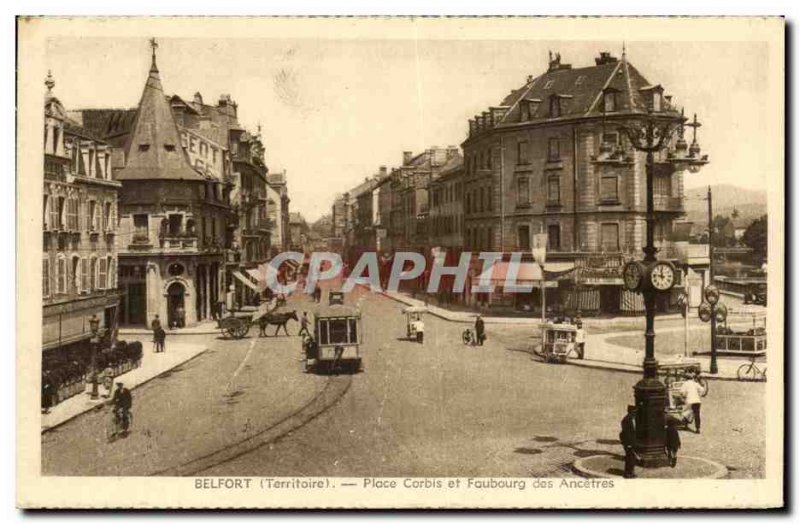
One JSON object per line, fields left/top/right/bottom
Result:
{"left": 17, "top": 17, "right": 785, "bottom": 508}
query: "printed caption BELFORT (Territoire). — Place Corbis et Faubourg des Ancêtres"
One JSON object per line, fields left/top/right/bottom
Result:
{"left": 194, "top": 477, "right": 615, "bottom": 491}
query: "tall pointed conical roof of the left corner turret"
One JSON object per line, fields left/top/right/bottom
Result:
{"left": 117, "top": 48, "right": 205, "bottom": 184}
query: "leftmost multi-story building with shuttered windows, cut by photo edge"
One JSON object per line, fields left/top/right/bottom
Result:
{"left": 42, "top": 73, "right": 120, "bottom": 368}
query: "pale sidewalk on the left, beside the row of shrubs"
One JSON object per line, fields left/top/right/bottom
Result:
{"left": 42, "top": 342, "right": 208, "bottom": 433}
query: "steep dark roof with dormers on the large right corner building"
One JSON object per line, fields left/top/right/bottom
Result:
{"left": 498, "top": 55, "right": 676, "bottom": 126}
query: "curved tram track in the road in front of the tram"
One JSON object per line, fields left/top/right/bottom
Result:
{"left": 149, "top": 375, "right": 353, "bottom": 477}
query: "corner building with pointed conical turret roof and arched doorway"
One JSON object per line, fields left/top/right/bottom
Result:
{"left": 110, "top": 50, "right": 231, "bottom": 326}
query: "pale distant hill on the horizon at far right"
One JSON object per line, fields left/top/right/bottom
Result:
{"left": 685, "top": 184, "right": 767, "bottom": 225}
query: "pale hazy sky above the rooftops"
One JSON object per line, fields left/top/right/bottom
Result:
{"left": 42, "top": 35, "right": 782, "bottom": 221}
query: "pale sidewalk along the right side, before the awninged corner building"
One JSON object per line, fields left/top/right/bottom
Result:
{"left": 382, "top": 291, "right": 745, "bottom": 380}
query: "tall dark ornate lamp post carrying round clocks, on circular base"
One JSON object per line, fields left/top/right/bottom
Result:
{"left": 621, "top": 107, "right": 707, "bottom": 467}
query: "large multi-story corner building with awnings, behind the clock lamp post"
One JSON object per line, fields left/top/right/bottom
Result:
{"left": 462, "top": 49, "right": 699, "bottom": 312}
